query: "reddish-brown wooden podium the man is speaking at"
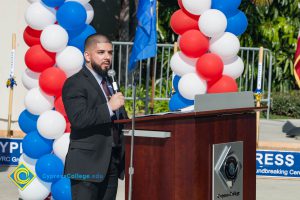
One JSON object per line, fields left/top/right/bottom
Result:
{"left": 117, "top": 107, "right": 265, "bottom": 200}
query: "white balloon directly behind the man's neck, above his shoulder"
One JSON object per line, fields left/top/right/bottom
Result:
{"left": 56, "top": 46, "right": 84, "bottom": 77}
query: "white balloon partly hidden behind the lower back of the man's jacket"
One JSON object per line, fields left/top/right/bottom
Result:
{"left": 53, "top": 133, "right": 70, "bottom": 163}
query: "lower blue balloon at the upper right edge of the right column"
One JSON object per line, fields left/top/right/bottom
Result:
{"left": 226, "top": 11, "right": 248, "bottom": 36}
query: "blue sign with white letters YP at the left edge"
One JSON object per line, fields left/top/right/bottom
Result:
{"left": 0, "top": 138, "right": 23, "bottom": 166}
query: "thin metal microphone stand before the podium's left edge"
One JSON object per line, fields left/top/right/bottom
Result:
{"left": 128, "top": 74, "right": 137, "bottom": 200}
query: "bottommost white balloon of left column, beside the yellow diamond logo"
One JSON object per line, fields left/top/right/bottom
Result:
{"left": 19, "top": 177, "right": 51, "bottom": 200}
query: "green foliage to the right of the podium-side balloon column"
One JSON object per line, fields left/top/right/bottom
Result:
{"left": 240, "top": 0, "right": 300, "bottom": 91}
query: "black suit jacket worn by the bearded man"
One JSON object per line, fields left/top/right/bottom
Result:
{"left": 62, "top": 66, "right": 127, "bottom": 182}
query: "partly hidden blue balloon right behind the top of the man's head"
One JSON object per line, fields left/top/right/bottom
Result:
{"left": 68, "top": 25, "right": 96, "bottom": 52}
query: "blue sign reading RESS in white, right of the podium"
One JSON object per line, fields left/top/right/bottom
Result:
{"left": 256, "top": 150, "right": 300, "bottom": 178}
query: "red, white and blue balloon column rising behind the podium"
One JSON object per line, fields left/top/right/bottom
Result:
{"left": 169, "top": 0, "right": 248, "bottom": 111}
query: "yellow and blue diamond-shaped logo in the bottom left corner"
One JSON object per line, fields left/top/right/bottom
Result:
{"left": 8, "top": 163, "right": 36, "bottom": 190}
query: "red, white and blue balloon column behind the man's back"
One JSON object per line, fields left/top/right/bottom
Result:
{"left": 19, "top": 0, "right": 96, "bottom": 200}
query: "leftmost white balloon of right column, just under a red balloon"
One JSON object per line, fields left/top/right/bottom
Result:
{"left": 170, "top": 51, "right": 197, "bottom": 76}
